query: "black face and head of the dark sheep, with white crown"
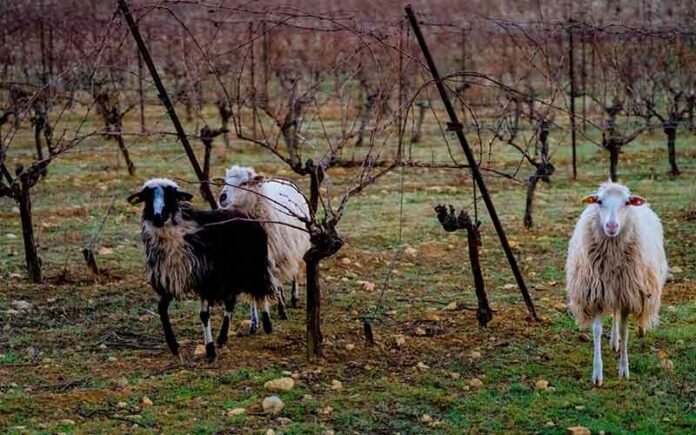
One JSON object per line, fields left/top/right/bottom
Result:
{"left": 128, "top": 178, "right": 193, "bottom": 228}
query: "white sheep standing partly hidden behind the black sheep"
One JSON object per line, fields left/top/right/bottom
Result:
{"left": 219, "top": 165, "right": 311, "bottom": 329}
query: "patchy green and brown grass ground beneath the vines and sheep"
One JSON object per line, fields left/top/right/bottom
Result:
{"left": 0, "top": 108, "right": 696, "bottom": 434}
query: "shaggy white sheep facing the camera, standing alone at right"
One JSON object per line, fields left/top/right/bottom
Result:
{"left": 566, "top": 182, "right": 668, "bottom": 386}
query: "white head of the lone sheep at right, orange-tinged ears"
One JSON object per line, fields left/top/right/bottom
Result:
{"left": 582, "top": 183, "right": 645, "bottom": 237}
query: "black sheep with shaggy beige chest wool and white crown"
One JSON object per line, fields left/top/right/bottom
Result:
{"left": 128, "top": 178, "right": 277, "bottom": 362}
